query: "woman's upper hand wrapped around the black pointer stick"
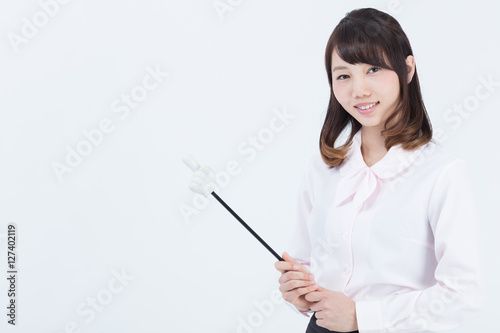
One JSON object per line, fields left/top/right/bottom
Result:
{"left": 274, "top": 252, "right": 318, "bottom": 311}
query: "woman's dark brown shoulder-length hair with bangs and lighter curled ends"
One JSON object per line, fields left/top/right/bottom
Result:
{"left": 319, "top": 8, "right": 432, "bottom": 168}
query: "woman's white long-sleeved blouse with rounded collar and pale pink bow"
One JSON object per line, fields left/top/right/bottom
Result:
{"left": 288, "top": 126, "right": 483, "bottom": 333}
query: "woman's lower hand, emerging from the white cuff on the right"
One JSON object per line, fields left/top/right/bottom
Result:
{"left": 305, "top": 286, "right": 358, "bottom": 332}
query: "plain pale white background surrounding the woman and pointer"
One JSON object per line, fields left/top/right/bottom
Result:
{"left": 0, "top": 0, "right": 500, "bottom": 333}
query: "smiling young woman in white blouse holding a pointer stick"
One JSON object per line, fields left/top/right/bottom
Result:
{"left": 275, "top": 8, "right": 483, "bottom": 333}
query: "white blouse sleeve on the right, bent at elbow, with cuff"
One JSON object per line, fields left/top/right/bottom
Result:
{"left": 356, "top": 160, "right": 484, "bottom": 333}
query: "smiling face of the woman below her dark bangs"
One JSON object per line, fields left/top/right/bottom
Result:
{"left": 332, "top": 51, "right": 400, "bottom": 131}
